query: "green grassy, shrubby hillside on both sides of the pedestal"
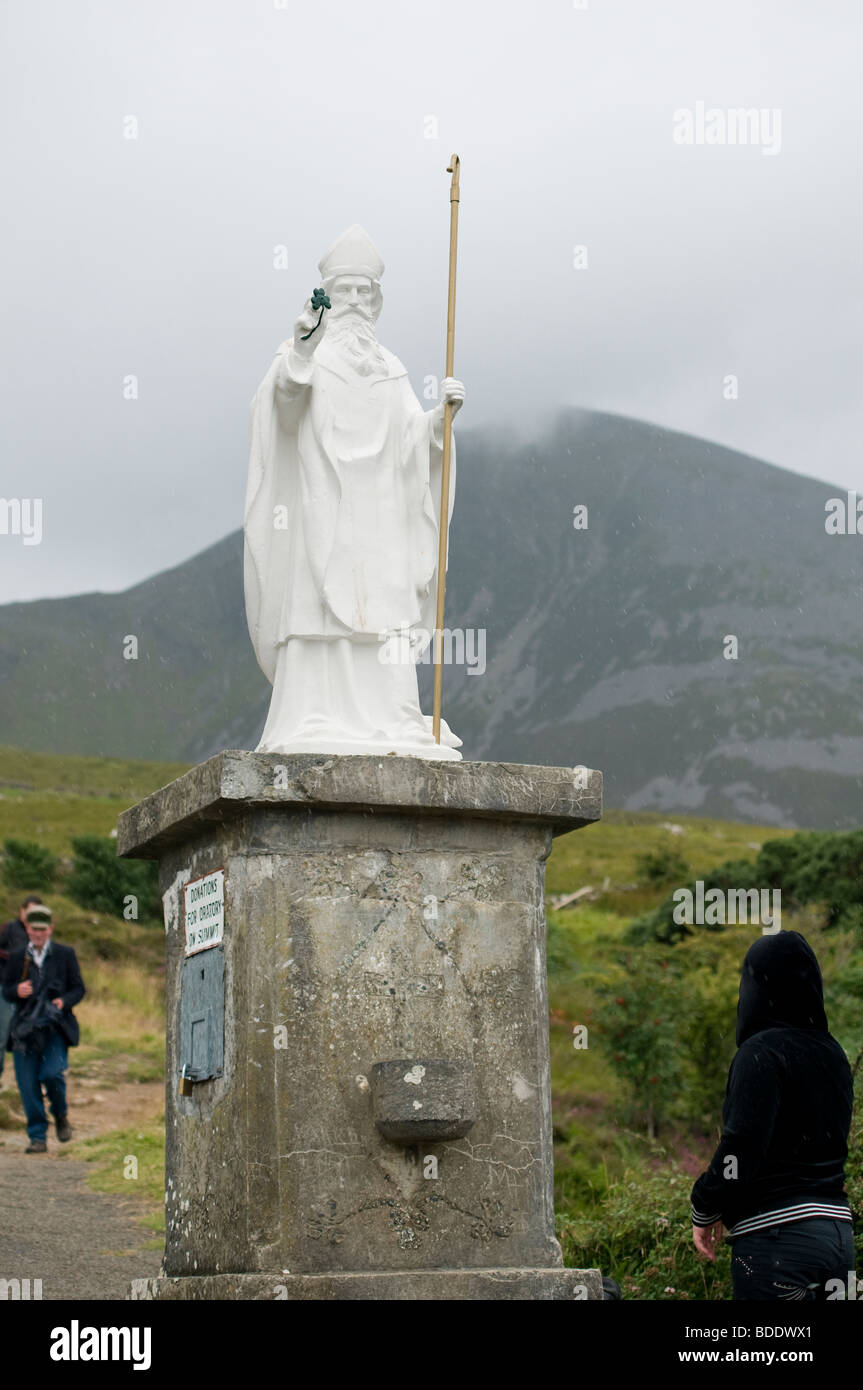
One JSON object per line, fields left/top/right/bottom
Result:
{"left": 0, "top": 749, "right": 863, "bottom": 1298}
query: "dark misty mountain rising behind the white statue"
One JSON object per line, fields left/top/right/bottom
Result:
{"left": 0, "top": 411, "right": 863, "bottom": 827}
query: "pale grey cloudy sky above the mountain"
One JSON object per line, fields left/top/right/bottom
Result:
{"left": 0, "top": 0, "right": 863, "bottom": 602}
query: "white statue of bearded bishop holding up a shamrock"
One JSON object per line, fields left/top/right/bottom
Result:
{"left": 245, "top": 225, "right": 464, "bottom": 760}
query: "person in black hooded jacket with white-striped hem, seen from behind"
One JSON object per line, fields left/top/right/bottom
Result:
{"left": 692, "top": 931, "right": 855, "bottom": 1301}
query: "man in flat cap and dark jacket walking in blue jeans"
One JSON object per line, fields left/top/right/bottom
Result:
{"left": 3, "top": 904, "right": 85, "bottom": 1154}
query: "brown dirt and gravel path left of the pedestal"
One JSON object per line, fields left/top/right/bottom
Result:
{"left": 0, "top": 1078, "right": 164, "bottom": 1301}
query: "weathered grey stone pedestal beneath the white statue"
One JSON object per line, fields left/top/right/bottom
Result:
{"left": 118, "top": 752, "right": 602, "bottom": 1300}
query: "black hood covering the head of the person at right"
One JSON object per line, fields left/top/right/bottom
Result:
{"left": 737, "top": 931, "right": 827, "bottom": 1047}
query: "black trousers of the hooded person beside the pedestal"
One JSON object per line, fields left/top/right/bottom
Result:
{"left": 731, "top": 1216, "right": 863, "bottom": 1302}
